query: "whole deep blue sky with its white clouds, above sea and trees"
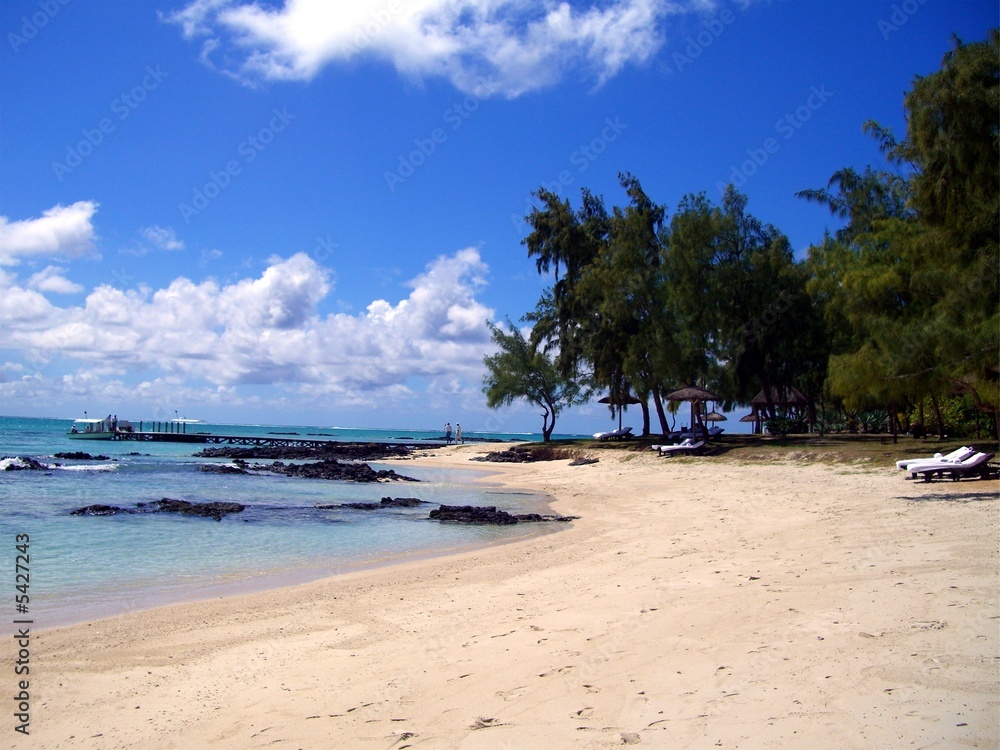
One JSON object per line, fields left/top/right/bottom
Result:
{"left": 0, "top": 0, "right": 998, "bottom": 432}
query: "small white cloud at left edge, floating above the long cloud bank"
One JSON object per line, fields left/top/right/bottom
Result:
{"left": 0, "top": 201, "right": 97, "bottom": 265}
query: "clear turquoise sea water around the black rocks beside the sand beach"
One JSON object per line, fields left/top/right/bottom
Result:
{"left": 0, "top": 417, "right": 568, "bottom": 632}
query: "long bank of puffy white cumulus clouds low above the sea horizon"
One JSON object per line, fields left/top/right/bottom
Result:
{"left": 0, "top": 249, "right": 493, "bottom": 404}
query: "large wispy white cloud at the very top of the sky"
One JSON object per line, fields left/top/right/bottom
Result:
{"left": 163, "top": 0, "right": 684, "bottom": 97}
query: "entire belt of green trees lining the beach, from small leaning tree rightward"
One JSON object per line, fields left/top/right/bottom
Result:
{"left": 500, "top": 30, "right": 1000, "bottom": 434}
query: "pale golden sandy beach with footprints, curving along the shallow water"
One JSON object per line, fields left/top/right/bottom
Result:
{"left": 9, "top": 445, "right": 1000, "bottom": 750}
